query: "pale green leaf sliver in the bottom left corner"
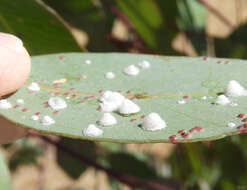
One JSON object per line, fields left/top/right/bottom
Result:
{"left": 0, "top": 149, "right": 11, "bottom": 190}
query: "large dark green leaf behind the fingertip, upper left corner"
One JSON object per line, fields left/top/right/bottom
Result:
{"left": 0, "top": 0, "right": 81, "bottom": 55}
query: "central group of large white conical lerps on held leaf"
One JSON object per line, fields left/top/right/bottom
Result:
{"left": 83, "top": 91, "right": 167, "bottom": 137}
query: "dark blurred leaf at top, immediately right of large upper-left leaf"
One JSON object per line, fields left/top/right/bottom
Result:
{"left": 44, "top": 0, "right": 116, "bottom": 52}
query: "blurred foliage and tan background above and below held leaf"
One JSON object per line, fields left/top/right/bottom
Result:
{"left": 0, "top": 0, "right": 247, "bottom": 190}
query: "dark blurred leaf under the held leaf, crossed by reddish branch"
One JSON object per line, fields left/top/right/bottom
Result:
{"left": 57, "top": 138, "right": 96, "bottom": 179}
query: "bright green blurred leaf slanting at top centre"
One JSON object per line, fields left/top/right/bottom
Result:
{"left": 116, "top": 0, "right": 176, "bottom": 54}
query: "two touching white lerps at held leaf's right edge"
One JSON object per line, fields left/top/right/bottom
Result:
{"left": 215, "top": 80, "right": 247, "bottom": 105}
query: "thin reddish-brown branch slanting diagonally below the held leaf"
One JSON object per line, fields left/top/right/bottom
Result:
{"left": 29, "top": 132, "right": 178, "bottom": 190}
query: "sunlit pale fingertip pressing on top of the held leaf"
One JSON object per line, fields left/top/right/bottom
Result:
{"left": 0, "top": 33, "right": 31, "bottom": 97}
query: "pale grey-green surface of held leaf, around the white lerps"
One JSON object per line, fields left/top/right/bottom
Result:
{"left": 0, "top": 53, "right": 247, "bottom": 143}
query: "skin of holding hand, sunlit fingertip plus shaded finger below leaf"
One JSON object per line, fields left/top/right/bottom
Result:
{"left": 0, "top": 33, "right": 31, "bottom": 144}
